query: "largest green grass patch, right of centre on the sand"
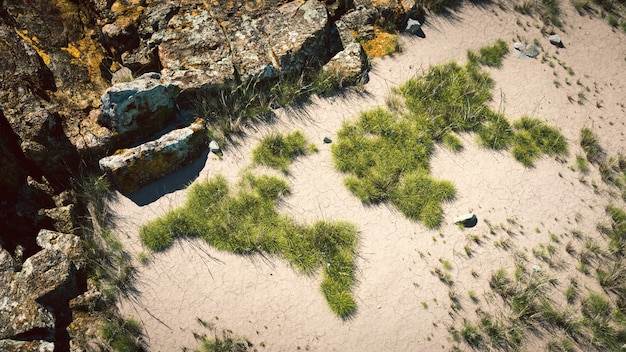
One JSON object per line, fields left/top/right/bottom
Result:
{"left": 332, "top": 41, "right": 567, "bottom": 228}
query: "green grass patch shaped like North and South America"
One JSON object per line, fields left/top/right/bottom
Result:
{"left": 140, "top": 174, "right": 357, "bottom": 318}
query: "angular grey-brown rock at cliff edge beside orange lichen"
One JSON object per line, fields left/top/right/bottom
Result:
{"left": 322, "top": 42, "right": 368, "bottom": 87}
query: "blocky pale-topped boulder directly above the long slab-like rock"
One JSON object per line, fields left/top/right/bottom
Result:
{"left": 98, "top": 73, "right": 180, "bottom": 140}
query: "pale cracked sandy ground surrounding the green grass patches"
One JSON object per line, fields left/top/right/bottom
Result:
{"left": 112, "top": 2, "right": 626, "bottom": 351}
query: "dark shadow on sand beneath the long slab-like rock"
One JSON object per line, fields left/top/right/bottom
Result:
{"left": 128, "top": 149, "right": 209, "bottom": 206}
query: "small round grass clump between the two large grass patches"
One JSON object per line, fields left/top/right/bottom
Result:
{"left": 252, "top": 131, "right": 312, "bottom": 172}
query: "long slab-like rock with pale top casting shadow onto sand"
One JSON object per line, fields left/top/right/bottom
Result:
{"left": 99, "top": 119, "right": 206, "bottom": 194}
